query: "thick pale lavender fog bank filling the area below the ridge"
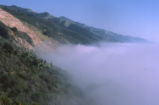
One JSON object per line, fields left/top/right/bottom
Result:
{"left": 35, "top": 43, "right": 159, "bottom": 105}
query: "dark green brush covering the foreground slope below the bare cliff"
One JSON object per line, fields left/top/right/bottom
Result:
{"left": 0, "top": 41, "right": 84, "bottom": 105}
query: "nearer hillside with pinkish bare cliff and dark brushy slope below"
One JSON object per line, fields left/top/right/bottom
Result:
{"left": 0, "top": 6, "right": 92, "bottom": 105}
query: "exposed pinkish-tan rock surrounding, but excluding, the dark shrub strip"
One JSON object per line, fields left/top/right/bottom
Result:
{"left": 0, "top": 8, "right": 42, "bottom": 49}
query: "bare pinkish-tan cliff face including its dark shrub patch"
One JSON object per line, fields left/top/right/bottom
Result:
{"left": 0, "top": 8, "right": 56, "bottom": 49}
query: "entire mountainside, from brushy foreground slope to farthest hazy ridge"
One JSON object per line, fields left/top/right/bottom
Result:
{"left": 0, "top": 5, "right": 144, "bottom": 105}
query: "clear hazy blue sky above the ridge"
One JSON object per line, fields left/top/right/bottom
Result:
{"left": 0, "top": 0, "right": 159, "bottom": 41}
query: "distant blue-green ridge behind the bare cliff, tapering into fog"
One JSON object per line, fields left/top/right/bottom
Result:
{"left": 0, "top": 6, "right": 144, "bottom": 44}
